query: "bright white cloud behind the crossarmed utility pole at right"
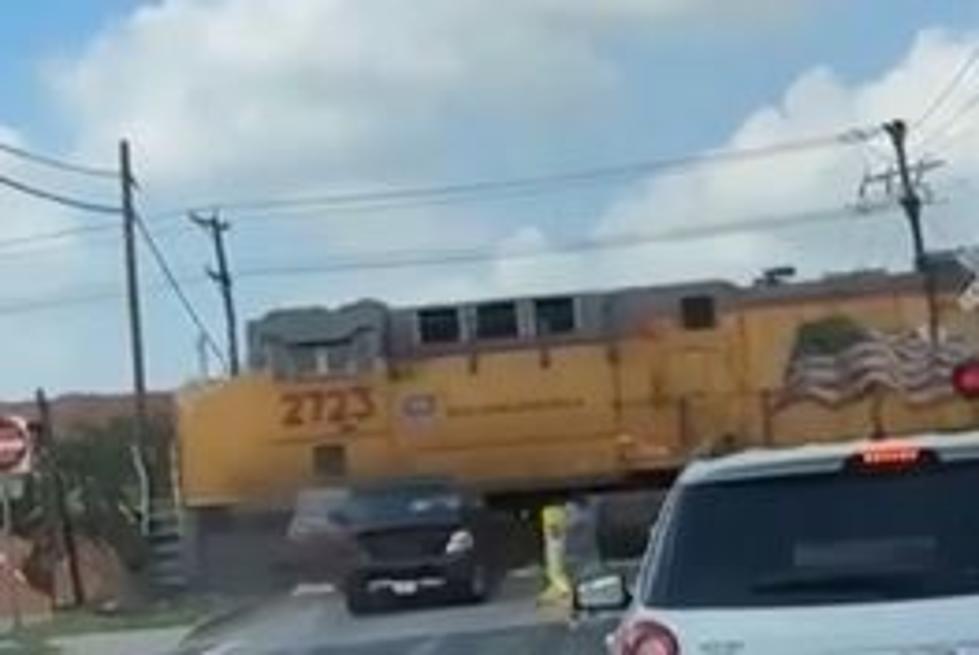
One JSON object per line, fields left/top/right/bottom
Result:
{"left": 483, "top": 30, "right": 979, "bottom": 292}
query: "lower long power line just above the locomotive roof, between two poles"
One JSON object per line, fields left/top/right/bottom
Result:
{"left": 236, "top": 201, "right": 897, "bottom": 278}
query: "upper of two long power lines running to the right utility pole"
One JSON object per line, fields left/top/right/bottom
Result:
{"left": 154, "top": 127, "right": 881, "bottom": 218}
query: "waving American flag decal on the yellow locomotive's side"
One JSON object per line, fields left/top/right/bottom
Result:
{"left": 778, "top": 317, "right": 975, "bottom": 406}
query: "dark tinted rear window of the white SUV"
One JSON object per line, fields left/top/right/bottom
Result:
{"left": 645, "top": 462, "right": 979, "bottom": 608}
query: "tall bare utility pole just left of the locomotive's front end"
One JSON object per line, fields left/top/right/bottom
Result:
{"left": 119, "top": 139, "right": 152, "bottom": 534}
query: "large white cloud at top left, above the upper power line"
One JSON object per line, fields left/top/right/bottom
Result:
{"left": 50, "top": 0, "right": 802, "bottom": 193}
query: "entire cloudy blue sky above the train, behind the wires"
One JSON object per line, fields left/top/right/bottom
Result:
{"left": 0, "top": 0, "right": 979, "bottom": 396}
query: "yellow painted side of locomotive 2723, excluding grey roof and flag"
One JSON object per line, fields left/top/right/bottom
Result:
{"left": 178, "top": 286, "right": 979, "bottom": 506}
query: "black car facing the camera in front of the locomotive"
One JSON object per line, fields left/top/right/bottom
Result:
{"left": 343, "top": 481, "right": 491, "bottom": 614}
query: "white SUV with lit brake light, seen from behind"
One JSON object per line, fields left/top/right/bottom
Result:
{"left": 577, "top": 433, "right": 979, "bottom": 655}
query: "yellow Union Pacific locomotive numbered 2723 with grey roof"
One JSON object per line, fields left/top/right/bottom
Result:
{"left": 178, "top": 258, "right": 979, "bottom": 510}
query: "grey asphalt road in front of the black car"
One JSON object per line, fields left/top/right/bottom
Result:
{"left": 178, "top": 579, "right": 615, "bottom": 655}
